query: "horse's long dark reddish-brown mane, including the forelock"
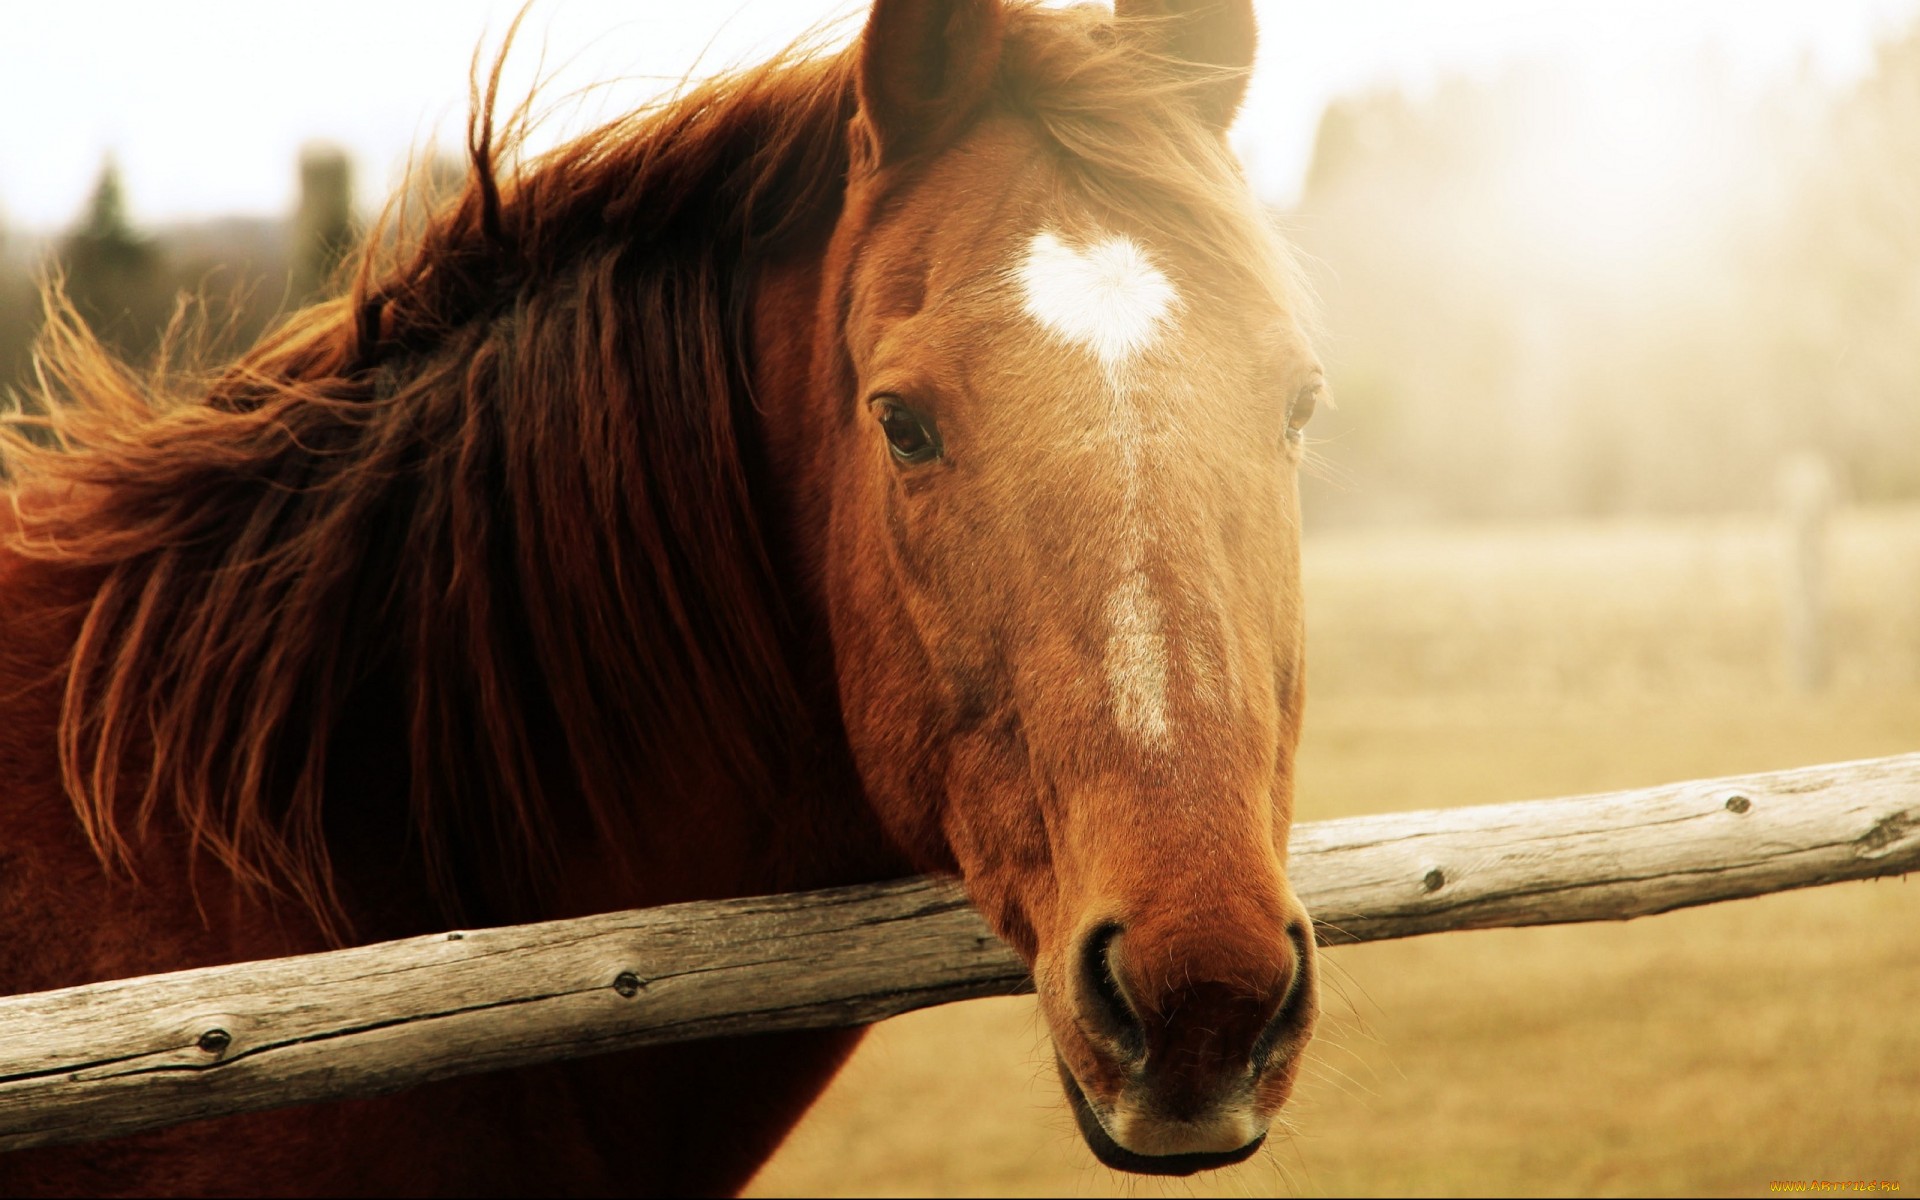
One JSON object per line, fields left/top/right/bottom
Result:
{"left": 0, "top": 8, "right": 1297, "bottom": 931}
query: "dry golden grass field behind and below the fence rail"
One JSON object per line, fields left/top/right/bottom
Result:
{"left": 751, "top": 509, "right": 1920, "bottom": 1196}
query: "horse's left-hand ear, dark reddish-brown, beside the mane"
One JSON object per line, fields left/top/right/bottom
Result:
{"left": 860, "top": 0, "right": 1002, "bottom": 161}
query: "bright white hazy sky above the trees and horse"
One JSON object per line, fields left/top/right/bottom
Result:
{"left": 0, "top": 0, "right": 1920, "bottom": 228}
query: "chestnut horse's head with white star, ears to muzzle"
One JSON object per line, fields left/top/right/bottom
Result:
{"left": 760, "top": 0, "right": 1321, "bottom": 1173}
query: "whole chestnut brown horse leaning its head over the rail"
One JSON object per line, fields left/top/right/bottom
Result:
{"left": 0, "top": 0, "right": 1319, "bottom": 1194}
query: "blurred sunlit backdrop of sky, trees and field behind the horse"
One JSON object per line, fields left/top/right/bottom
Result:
{"left": 0, "top": 0, "right": 1920, "bottom": 1194}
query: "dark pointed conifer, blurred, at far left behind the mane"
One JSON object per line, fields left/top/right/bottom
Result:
{"left": 58, "top": 157, "right": 171, "bottom": 361}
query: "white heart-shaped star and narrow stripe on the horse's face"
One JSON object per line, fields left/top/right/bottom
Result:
{"left": 1020, "top": 232, "right": 1179, "bottom": 745}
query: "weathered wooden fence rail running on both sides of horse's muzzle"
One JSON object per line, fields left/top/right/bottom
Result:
{"left": 0, "top": 755, "right": 1920, "bottom": 1150}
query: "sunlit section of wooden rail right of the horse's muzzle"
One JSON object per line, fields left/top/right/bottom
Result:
{"left": 1288, "top": 755, "right": 1920, "bottom": 945}
